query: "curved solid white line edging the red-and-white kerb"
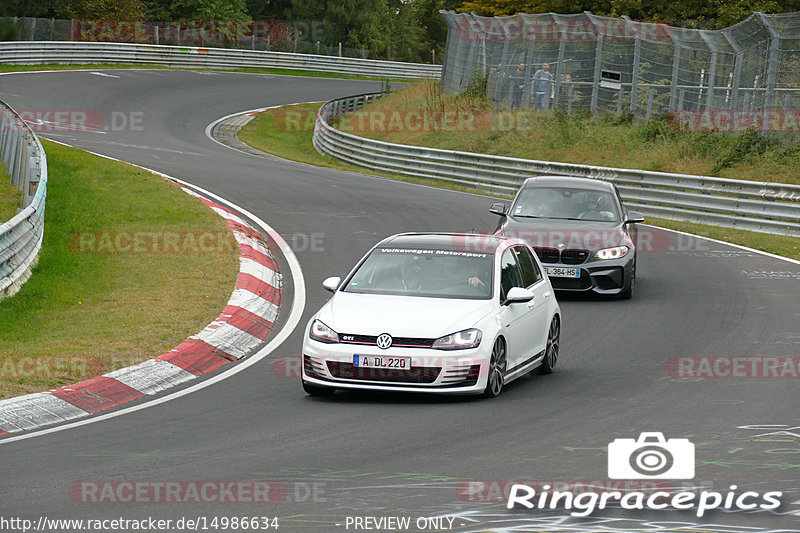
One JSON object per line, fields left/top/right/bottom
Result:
{"left": 0, "top": 140, "right": 306, "bottom": 445}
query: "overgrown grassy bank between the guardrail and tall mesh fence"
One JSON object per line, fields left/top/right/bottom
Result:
{"left": 332, "top": 81, "right": 800, "bottom": 184}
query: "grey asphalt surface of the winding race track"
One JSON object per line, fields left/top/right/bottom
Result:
{"left": 0, "top": 70, "right": 800, "bottom": 531}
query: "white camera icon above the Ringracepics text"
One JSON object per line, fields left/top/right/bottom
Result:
{"left": 608, "top": 432, "right": 694, "bottom": 479}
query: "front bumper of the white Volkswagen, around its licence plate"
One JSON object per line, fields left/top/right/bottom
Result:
{"left": 302, "top": 338, "right": 489, "bottom": 394}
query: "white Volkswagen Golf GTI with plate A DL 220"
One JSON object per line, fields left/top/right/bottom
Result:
{"left": 302, "top": 233, "right": 561, "bottom": 397}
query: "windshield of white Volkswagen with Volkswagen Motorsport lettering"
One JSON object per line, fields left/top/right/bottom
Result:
{"left": 343, "top": 248, "right": 494, "bottom": 300}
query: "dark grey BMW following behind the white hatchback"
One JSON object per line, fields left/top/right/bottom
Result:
{"left": 490, "top": 176, "right": 644, "bottom": 299}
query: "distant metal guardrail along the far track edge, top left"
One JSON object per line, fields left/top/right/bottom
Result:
{"left": 0, "top": 41, "right": 442, "bottom": 79}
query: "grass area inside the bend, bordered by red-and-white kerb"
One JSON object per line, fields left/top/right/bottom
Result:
{"left": 0, "top": 142, "right": 238, "bottom": 398}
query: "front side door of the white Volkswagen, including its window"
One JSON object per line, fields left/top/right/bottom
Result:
{"left": 499, "top": 248, "right": 534, "bottom": 371}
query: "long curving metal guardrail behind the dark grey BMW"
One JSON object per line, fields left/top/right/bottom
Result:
{"left": 313, "top": 93, "right": 800, "bottom": 236}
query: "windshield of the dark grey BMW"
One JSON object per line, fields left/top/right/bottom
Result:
{"left": 511, "top": 187, "right": 620, "bottom": 222}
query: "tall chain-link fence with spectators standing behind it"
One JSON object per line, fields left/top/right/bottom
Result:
{"left": 441, "top": 11, "right": 800, "bottom": 131}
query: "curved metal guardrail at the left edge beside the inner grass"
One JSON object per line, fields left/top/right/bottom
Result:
{"left": 0, "top": 101, "right": 47, "bottom": 299}
